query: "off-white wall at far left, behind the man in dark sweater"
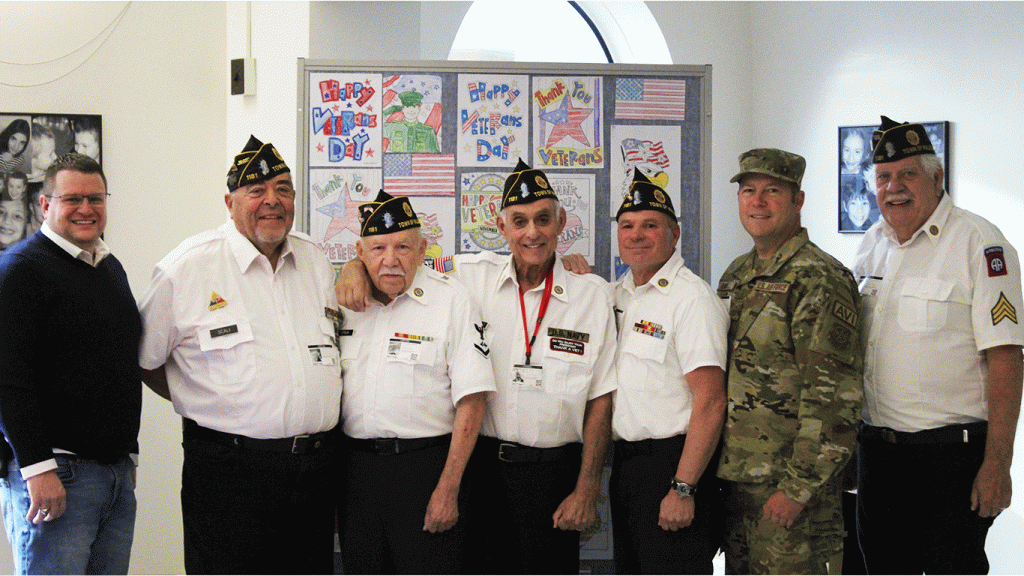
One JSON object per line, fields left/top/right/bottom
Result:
{"left": 0, "top": 2, "right": 228, "bottom": 574}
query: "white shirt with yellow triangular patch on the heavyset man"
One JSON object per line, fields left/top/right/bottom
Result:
{"left": 139, "top": 221, "right": 342, "bottom": 439}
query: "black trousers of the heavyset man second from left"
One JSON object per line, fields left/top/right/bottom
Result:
{"left": 181, "top": 425, "right": 337, "bottom": 574}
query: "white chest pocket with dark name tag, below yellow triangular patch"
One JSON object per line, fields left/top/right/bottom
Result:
{"left": 197, "top": 317, "right": 256, "bottom": 383}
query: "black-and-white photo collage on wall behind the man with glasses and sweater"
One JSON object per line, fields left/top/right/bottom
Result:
{"left": 0, "top": 113, "right": 102, "bottom": 252}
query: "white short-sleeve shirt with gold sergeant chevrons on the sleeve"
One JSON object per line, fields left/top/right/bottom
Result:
{"left": 854, "top": 194, "right": 1024, "bottom": 431}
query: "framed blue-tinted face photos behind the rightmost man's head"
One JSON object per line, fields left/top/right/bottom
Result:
{"left": 837, "top": 121, "right": 949, "bottom": 234}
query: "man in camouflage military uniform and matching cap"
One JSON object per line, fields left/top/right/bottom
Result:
{"left": 718, "top": 149, "right": 863, "bottom": 574}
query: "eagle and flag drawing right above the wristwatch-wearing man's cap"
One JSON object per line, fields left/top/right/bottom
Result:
{"left": 608, "top": 124, "right": 682, "bottom": 216}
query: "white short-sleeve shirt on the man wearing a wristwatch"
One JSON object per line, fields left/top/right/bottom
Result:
{"left": 611, "top": 252, "right": 729, "bottom": 441}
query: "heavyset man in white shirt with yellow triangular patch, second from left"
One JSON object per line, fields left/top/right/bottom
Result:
{"left": 139, "top": 137, "right": 342, "bottom": 574}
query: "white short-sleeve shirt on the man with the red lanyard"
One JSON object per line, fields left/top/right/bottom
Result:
{"left": 454, "top": 252, "right": 616, "bottom": 448}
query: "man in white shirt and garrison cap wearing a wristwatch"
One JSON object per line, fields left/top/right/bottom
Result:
{"left": 610, "top": 168, "right": 729, "bottom": 574}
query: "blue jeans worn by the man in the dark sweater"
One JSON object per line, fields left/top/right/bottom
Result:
{"left": 0, "top": 454, "right": 135, "bottom": 574}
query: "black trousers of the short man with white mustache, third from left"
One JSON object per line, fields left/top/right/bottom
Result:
{"left": 339, "top": 437, "right": 467, "bottom": 574}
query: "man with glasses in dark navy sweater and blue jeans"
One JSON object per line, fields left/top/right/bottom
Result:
{"left": 0, "top": 154, "right": 142, "bottom": 574}
